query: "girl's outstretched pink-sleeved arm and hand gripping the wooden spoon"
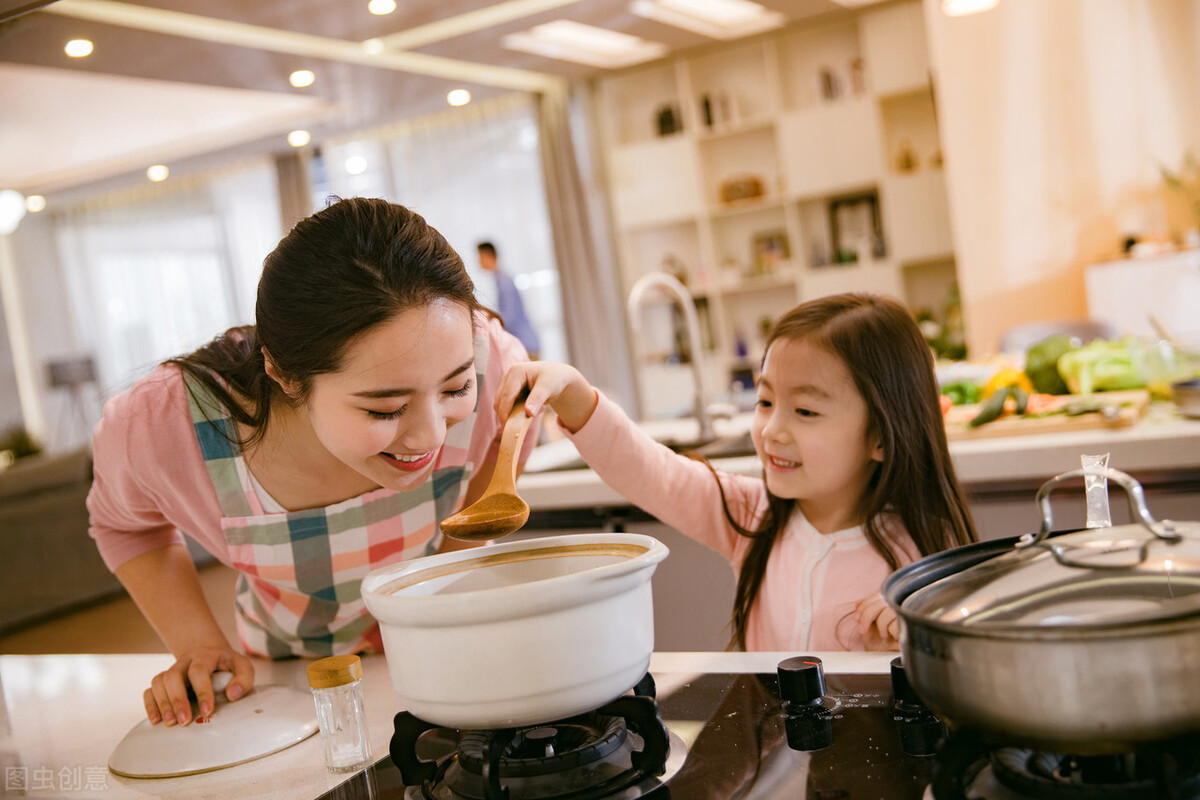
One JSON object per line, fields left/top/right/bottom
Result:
{"left": 497, "top": 361, "right": 766, "bottom": 560}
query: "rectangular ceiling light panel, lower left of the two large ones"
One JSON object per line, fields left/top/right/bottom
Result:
{"left": 504, "top": 19, "right": 667, "bottom": 70}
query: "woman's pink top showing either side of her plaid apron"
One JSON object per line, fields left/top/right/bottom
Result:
{"left": 88, "top": 319, "right": 536, "bottom": 570}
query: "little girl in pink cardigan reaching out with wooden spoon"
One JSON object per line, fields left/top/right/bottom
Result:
{"left": 497, "top": 294, "right": 974, "bottom": 651}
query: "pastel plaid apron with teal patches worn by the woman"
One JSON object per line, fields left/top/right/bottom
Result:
{"left": 185, "top": 336, "right": 488, "bottom": 658}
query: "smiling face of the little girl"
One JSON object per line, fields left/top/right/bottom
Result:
{"left": 751, "top": 339, "right": 883, "bottom": 533}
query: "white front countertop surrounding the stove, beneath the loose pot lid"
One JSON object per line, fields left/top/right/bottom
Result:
{"left": 0, "top": 652, "right": 896, "bottom": 800}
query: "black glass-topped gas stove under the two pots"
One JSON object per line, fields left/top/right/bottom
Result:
{"left": 320, "top": 656, "right": 1200, "bottom": 800}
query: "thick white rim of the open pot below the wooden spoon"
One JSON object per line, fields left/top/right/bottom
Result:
{"left": 361, "top": 533, "right": 668, "bottom": 627}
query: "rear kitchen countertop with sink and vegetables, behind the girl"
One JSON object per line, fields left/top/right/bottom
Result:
{"left": 517, "top": 403, "right": 1200, "bottom": 513}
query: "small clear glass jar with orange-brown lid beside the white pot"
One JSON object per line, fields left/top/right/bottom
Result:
{"left": 307, "top": 656, "right": 371, "bottom": 772}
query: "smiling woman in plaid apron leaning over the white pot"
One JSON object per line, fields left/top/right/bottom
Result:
{"left": 88, "top": 198, "right": 534, "bottom": 726}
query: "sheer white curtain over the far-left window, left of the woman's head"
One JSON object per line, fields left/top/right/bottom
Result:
{"left": 56, "top": 161, "right": 282, "bottom": 393}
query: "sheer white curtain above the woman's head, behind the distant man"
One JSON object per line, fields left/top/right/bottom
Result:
{"left": 313, "top": 95, "right": 569, "bottom": 361}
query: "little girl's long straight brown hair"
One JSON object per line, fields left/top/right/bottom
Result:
{"left": 718, "top": 293, "right": 976, "bottom": 649}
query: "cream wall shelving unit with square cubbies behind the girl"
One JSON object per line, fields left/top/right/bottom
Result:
{"left": 599, "top": 1, "right": 955, "bottom": 416}
